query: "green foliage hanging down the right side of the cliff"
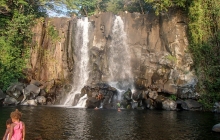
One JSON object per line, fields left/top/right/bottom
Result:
{"left": 145, "top": 0, "right": 220, "bottom": 110}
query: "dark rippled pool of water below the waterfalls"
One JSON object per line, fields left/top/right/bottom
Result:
{"left": 0, "top": 106, "right": 220, "bottom": 140}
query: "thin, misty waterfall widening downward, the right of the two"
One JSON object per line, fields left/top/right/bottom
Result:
{"left": 108, "top": 16, "right": 133, "bottom": 100}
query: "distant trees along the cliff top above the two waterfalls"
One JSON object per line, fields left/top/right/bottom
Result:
{"left": 45, "top": 0, "right": 151, "bottom": 16}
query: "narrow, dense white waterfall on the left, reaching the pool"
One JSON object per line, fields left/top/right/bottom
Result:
{"left": 64, "top": 17, "right": 90, "bottom": 107}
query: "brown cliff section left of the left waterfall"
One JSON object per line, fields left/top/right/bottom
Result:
{"left": 30, "top": 18, "right": 70, "bottom": 90}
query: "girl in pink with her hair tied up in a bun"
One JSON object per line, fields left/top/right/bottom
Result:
{"left": 9, "top": 109, "right": 25, "bottom": 140}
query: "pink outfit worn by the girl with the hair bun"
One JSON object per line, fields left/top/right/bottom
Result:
{"left": 11, "top": 121, "right": 23, "bottom": 140}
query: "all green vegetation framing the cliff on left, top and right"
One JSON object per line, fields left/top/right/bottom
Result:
{"left": 0, "top": 0, "right": 220, "bottom": 109}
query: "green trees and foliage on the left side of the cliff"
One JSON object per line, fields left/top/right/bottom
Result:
{"left": 0, "top": 0, "right": 46, "bottom": 90}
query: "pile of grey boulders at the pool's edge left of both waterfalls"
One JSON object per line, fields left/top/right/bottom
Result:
{"left": 0, "top": 80, "right": 56, "bottom": 106}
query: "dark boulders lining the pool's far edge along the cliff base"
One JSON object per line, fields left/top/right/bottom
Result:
{"left": 0, "top": 80, "right": 208, "bottom": 112}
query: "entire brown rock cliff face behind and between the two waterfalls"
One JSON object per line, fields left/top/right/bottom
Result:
{"left": 29, "top": 11, "right": 197, "bottom": 102}
